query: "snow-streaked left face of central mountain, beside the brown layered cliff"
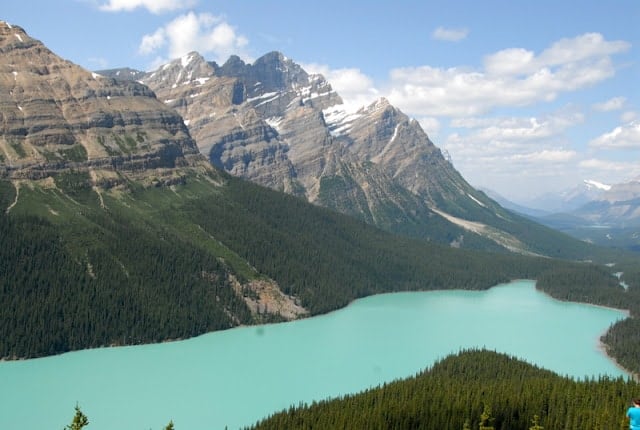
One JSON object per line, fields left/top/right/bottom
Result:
{"left": 142, "top": 53, "right": 299, "bottom": 193}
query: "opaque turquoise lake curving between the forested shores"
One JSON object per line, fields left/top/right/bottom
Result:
{"left": 0, "top": 281, "right": 627, "bottom": 430}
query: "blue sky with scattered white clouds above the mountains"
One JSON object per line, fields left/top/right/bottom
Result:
{"left": 0, "top": 0, "right": 640, "bottom": 202}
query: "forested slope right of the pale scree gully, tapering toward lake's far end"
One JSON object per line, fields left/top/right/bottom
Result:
{"left": 186, "top": 179, "right": 564, "bottom": 314}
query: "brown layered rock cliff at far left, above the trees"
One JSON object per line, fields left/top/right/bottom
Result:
{"left": 0, "top": 22, "right": 198, "bottom": 183}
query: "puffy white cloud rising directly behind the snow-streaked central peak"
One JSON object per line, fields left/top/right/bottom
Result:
{"left": 138, "top": 12, "right": 248, "bottom": 66}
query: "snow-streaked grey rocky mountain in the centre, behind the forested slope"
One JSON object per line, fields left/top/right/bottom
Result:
{"left": 100, "top": 52, "right": 600, "bottom": 255}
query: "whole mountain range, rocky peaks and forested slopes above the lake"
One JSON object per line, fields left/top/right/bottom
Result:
{"left": 0, "top": 22, "right": 636, "bottom": 358}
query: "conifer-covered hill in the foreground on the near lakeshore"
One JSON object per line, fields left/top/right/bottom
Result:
{"left": 251, "top": 345, "right": 640, "bottom": 430}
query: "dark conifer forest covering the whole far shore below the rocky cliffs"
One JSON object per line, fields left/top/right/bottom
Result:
{"left": 0, "top": 174, "right": 640, "bottom": 369}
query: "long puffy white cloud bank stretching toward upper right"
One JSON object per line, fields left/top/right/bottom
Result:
{"left": 388, "top": 33, "right": 630, "bottom": 117}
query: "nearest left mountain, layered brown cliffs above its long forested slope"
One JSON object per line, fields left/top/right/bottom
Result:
{"left": 0, "top": 22, "right": 640, "bottom": 376}
